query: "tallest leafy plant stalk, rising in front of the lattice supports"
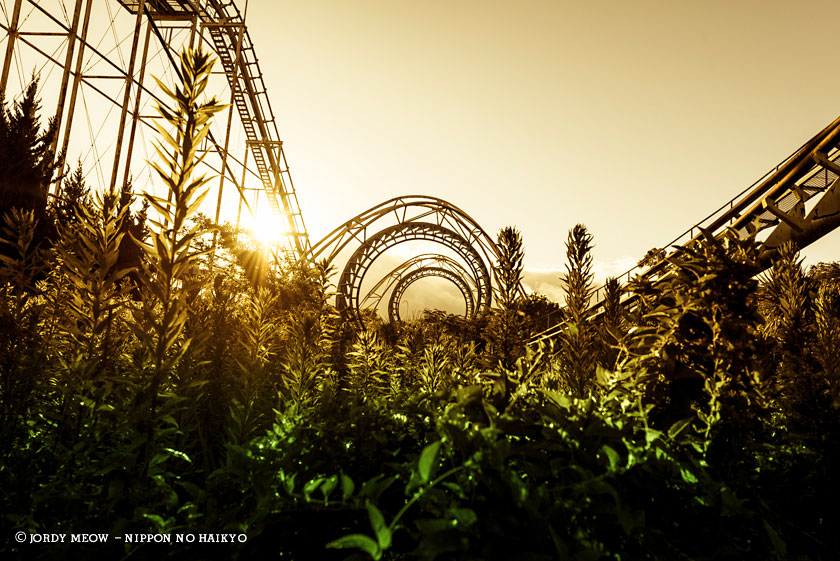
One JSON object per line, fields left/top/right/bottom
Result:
{"left": 129, "top": 49, "right": 225, "bottom": 472}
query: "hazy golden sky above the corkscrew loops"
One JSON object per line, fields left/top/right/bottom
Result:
{"left": 4, "top": 0, "right": 840, "bottom": 313}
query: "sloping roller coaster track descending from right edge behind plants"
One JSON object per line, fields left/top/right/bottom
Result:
{"left": 530, "top": 112, "right": 840, "bottom": 344}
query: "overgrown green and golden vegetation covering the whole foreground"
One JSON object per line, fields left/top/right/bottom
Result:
{"left": 0, "top": 52, "right": 840, "bottom": 561}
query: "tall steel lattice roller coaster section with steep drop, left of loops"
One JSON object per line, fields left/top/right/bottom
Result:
{"left": 0, "top": 0, "right": 309, "bottom": 259}
